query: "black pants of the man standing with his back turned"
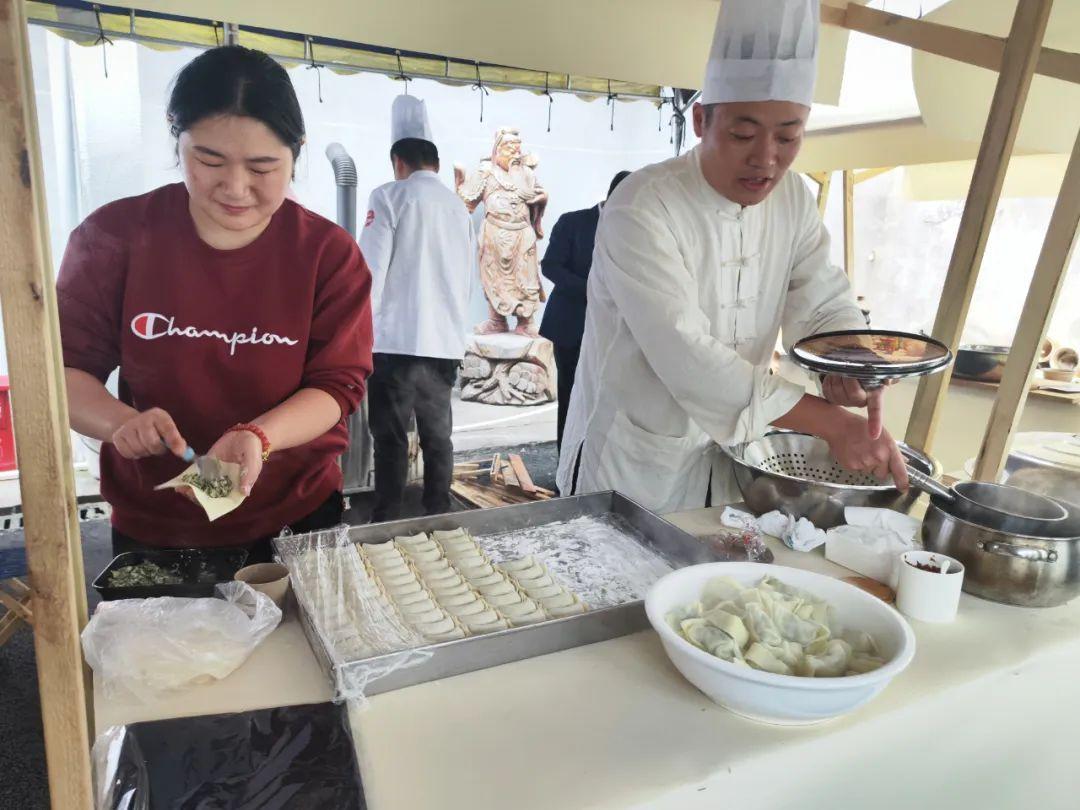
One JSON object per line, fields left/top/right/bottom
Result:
{"left": 367, "top": 354, "right": 458, "bottom": 523}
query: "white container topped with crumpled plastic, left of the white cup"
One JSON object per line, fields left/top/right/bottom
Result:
{"left": 825, "top": 507, "right": 920, "bottom": 590}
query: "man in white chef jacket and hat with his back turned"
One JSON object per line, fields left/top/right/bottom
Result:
{"left": 360, "top": 95, "right": 477, "bottom": 521}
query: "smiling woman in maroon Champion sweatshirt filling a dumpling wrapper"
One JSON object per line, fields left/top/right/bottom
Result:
{"left": 57, "top": 46, "right": 372, "bottom": 559}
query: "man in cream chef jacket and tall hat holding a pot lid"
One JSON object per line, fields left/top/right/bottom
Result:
{"left": 558, "top": 0, "right": 907, "bottom": 512}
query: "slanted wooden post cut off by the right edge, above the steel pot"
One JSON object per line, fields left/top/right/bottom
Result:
{"left": 975, "top": 126, "right": 1080, "bottom": 481}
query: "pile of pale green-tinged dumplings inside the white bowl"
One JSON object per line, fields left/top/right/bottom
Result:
{"left": 666, "top": 577, "right": 885, "bottom": 677}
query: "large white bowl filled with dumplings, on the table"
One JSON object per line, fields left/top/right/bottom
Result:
{"left": 645, "top": 563, "right": 915, "bottom": 726}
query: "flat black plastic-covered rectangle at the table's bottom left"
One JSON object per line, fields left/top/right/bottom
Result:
{"left": 93, "top": 703, "right": 366, "bottom": 810}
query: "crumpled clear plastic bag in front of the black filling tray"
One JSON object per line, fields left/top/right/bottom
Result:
{"left": 82, "top": 582, "right": 281, "bottom": 702}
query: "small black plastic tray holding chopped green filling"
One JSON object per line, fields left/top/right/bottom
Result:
{"left": 94, "top": 549, "right": 247, "bottom": 600}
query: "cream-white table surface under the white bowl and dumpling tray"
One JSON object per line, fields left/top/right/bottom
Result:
{"left": 95, "top": 509, "right": 1080, "bottom": 810}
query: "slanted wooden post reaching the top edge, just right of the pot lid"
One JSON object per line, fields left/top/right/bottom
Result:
{"left": 906, "top": 0, "right": 1053, "bottom": 450}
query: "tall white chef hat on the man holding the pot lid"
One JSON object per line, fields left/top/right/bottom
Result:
{"left": 701, "top": 0, "right": 821, "bottom": 107}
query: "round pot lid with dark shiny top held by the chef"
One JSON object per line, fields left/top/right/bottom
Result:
{"left": 792, "top": 329, "right": 953, "bottom": 383}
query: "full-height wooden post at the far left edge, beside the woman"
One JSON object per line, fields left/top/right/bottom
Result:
{"left": 0, "top": 0, "right": 93, "bottom": 810}
